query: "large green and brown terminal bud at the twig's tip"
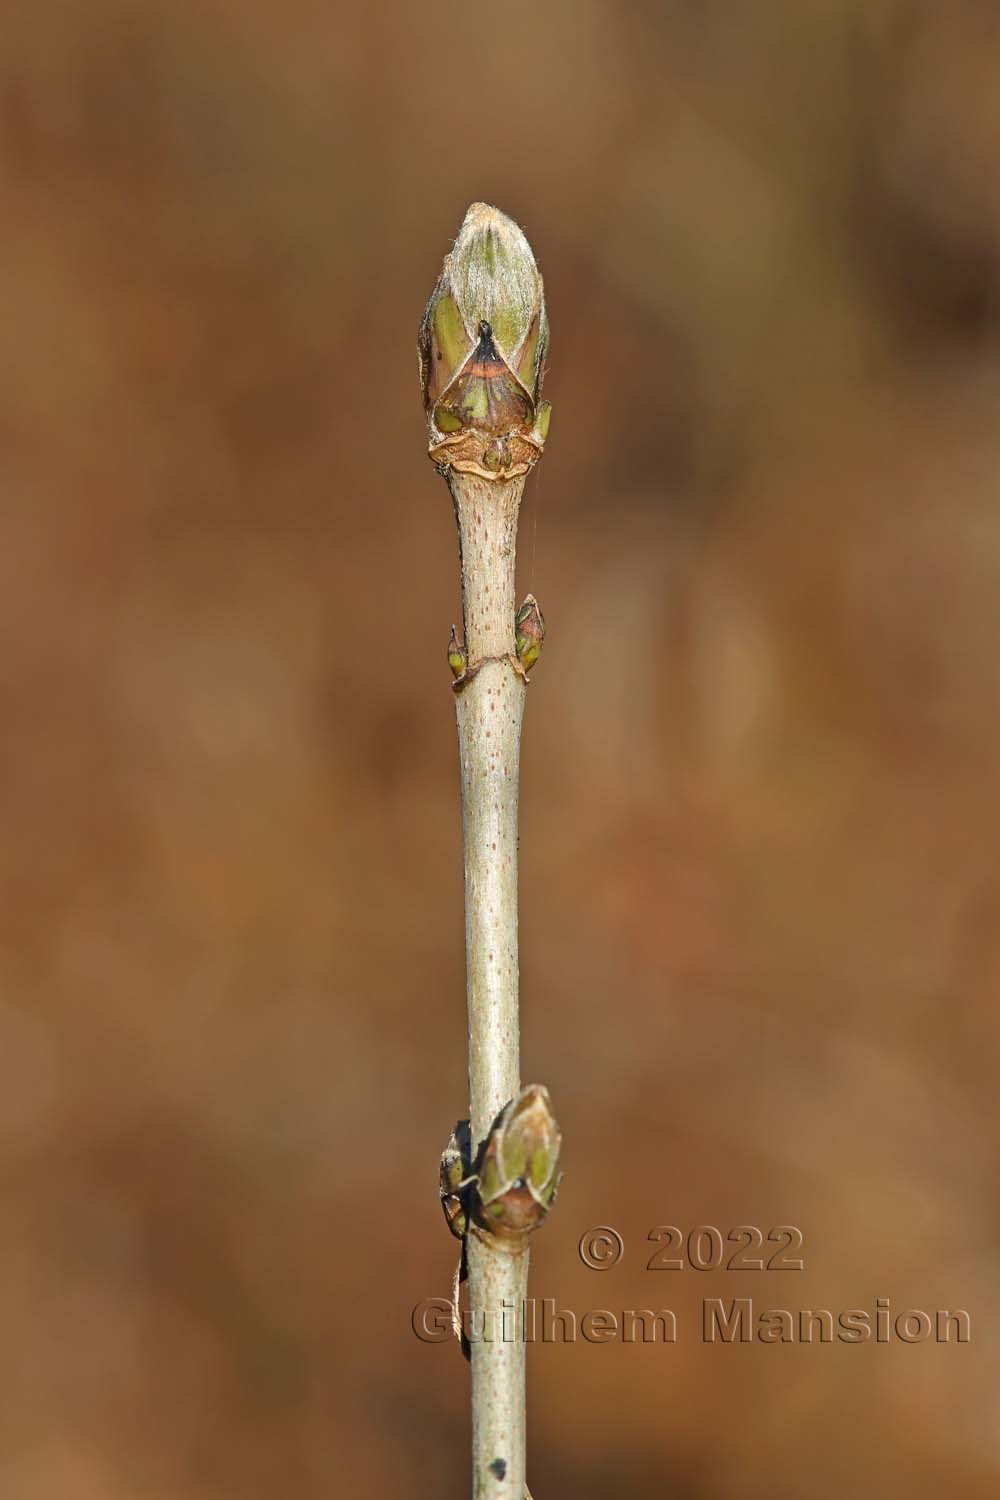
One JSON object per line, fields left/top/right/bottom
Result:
{"left": 418, "top": 203, "right": 549, "bottom": 479}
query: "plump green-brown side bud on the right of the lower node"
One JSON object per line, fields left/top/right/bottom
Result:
{"left": 478, "top": 1085, "right": 562, "bottom": 1238}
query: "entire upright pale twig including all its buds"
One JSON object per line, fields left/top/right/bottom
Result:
{"left": 420, "top": 204, "right": 559, "bottom": 1500}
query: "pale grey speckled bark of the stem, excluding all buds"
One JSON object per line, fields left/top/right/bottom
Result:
{"left": 448, "top": 471, "right": 528, "bottom": 1500}
